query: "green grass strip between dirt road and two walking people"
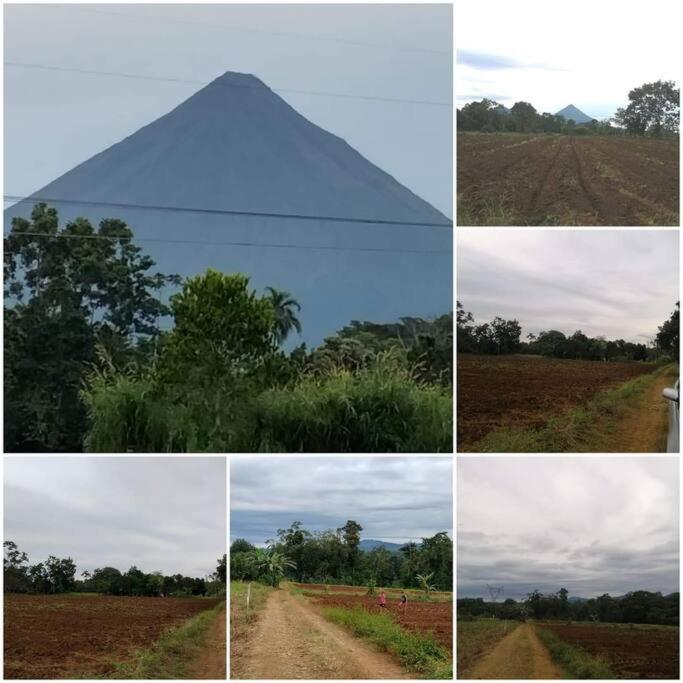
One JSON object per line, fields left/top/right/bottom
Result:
{"left": 322, "top": 607, "right": 453, "bottom": 679}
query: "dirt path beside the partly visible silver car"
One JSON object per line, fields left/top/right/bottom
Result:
{"left": 606, "top": 371, "right": 676, "bottom": 453}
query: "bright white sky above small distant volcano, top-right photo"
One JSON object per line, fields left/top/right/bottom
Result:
{"left": 455, "top": 0, "right": 681, "bottom": 118}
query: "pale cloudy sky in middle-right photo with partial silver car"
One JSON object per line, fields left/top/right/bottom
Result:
{"left": 456, "top": 228, "right": 679, "bottom": 343}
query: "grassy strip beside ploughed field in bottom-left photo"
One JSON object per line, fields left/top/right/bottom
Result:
{"left": 100, "top": 603, "right": 225, "bottom": 679}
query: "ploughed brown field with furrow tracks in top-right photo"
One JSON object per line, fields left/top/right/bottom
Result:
{"left": 457, "top": 133, "right": 679, "bottom": 225}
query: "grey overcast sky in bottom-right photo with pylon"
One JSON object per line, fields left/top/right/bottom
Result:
{"left": 457, "top": 456, "right": 679, "bottom": 599}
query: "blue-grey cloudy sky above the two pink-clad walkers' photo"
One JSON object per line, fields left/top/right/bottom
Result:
{"left": 230, "top": 456, "right": 453, "bottom": 544}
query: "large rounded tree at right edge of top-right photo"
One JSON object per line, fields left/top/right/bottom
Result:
{"left": 614, "top": 80, "right": 680, "bottom": 137}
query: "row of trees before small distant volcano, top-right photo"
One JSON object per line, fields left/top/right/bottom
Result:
{"left": 457, "top": 80, "right": 680, "bottom": 137}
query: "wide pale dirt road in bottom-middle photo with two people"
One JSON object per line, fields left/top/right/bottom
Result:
{"left": 232, "top": 590, "right": 411, "bottom": 679}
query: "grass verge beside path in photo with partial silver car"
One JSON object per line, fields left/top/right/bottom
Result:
{"left": 463, "top": 364, "right": 678, "bottom": 453}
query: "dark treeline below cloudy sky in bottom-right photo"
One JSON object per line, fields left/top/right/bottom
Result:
{"left": 457, "top": 588, "right": 680, "bottom": 626}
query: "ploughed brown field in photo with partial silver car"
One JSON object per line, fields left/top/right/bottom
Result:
{"left": 457, "top": 354, "right": 656, "bottom": 451}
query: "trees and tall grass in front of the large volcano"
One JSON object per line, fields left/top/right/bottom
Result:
{"left": 4, "top": 203, "right": 453, "bottom": 452}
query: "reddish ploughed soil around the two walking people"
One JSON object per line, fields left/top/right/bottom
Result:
{"left": 302, "top": 584, "right": 453, "bottom": 652}
